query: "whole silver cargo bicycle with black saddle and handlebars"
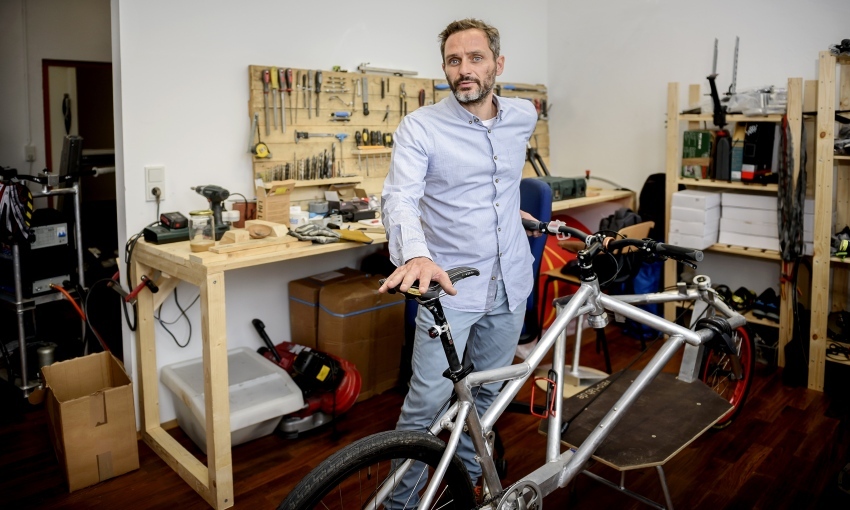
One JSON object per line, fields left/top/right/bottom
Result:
{"left": 278, "top": 220, "right": 754, "bottom": 510}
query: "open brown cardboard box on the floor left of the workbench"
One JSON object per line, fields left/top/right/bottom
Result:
{"left": 42, "top": 352, "right": 139, "bottom": 492}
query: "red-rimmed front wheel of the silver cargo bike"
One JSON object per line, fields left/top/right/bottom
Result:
{"left": 700, "top": 327, "right": 756, "bottom": 429}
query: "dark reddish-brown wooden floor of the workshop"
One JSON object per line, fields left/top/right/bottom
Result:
{"left": 0, "top": 328, "right": 850, "bottom": 510}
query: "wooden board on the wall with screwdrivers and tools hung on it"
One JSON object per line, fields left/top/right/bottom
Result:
{"left": 248, "top": 65, "right": 549, "bottom": 205}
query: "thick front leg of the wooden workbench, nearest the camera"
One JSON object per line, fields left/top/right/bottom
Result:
{"left": 200, "top": 273, "right": 233, "bottom": 509}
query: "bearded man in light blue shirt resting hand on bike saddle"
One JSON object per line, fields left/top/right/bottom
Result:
{"left": 380, "top": 19, "right": 537, "bottom": 504}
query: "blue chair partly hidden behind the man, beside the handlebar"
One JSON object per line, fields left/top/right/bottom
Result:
{"left": 519, "top": 177, "right": 552, "bottom": 344}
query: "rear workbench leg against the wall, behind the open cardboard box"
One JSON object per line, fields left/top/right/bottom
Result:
{"left": 130, "top": 262, "right": 160, "bottom": 433}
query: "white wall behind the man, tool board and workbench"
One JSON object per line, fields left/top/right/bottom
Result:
{"left": 112, "top": 0, "right": 547, "bottom": 421}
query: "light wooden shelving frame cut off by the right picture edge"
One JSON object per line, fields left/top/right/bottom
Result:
{"left": 808, "top": 51, "right": 850, "bottom": 391}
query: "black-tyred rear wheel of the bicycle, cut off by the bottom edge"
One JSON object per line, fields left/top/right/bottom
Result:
{"left": 277, "top": 430, "right": 476, "bottom": 510}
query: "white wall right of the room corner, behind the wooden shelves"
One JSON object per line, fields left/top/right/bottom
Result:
{"left": 547, "top": 0, "right": 850, "bottom": 291}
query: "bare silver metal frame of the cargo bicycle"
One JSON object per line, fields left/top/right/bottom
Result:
{"left": 369, "top": 281, "right": 746, "bottom": 508}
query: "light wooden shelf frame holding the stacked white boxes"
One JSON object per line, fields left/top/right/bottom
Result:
{"left": 664, "top": 78, "right": 803, "bottom": 366}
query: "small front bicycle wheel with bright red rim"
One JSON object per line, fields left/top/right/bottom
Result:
{"left": 702, "top": 328, "right": 753, "bottom": 426}
